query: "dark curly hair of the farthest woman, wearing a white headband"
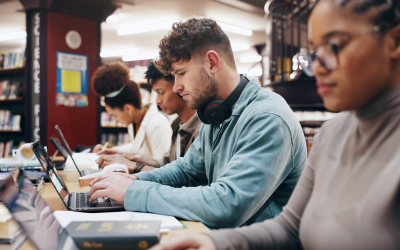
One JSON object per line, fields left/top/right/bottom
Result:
{"left": 92, "top": 62, "right": 142, "bottom": 110}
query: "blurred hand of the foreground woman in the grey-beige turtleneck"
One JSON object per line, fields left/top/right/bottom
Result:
{"left": 149, "top": 232, "right": 217, "bottom": 250}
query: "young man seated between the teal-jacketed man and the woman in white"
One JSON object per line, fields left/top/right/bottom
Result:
{"left": 97, "top": 62, "right": 201, "bottom": 171}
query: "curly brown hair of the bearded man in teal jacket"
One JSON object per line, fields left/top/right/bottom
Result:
{"left": 156, "top": 18, "right": 236, "bottom": 75}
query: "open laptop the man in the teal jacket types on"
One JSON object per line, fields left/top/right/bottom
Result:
{"left": 31, "top": 141, "right": 124, "bottom": 212}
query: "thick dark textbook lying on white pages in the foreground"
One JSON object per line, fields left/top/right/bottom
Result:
{"left": 66, "top": 221, "right": 161, "bottom": 250}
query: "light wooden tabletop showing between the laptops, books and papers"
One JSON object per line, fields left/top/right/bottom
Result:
{"left": 5, "top": 171, "right": 210, "bottom": 250}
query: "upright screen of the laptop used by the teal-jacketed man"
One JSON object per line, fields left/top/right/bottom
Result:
{"left": 31, "top": 141, "right": 70, "bottom": 208}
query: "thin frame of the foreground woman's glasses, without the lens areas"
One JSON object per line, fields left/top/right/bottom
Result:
{"left": 297, "top": 21, "right": 400, "bottom": 76}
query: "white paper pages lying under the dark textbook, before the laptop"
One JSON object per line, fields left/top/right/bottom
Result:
{"left": 54, "top": 211, "right": 183, "bottom": 232}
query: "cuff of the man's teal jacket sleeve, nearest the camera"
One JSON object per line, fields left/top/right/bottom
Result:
{"left": 124, "top": 181, "right": 157, "bottom": 212}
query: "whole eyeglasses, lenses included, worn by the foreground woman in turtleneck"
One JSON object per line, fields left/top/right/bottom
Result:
{"left": 297, "top": 23, "right": 398, "bottom": 76}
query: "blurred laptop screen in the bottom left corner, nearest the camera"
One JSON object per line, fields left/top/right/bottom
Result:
{"left": 0, "top": 173, "right": 77, "bottom": 250}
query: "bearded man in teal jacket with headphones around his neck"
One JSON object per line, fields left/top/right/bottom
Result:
{"left": 91, "top": 18, "right": 307, "bottom": 228}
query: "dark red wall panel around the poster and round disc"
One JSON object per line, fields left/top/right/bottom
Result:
{"left": 47, "top": 12, "right": 100, "bottom": 155}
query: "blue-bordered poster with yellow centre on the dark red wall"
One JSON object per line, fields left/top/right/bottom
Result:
{"left": 56, "top": 51, "right": 89, "bottom": 107}
